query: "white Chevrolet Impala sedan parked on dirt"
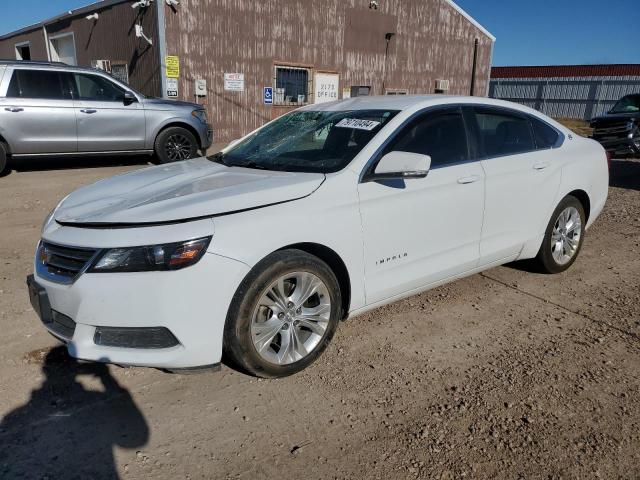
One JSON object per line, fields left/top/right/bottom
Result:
{"left": 28, "top": 96, "right": 608, "bottom": 377}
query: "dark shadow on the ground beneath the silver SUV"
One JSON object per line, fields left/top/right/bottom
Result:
{"left": 0, "top": 155, "right": 155, "bottom": 177}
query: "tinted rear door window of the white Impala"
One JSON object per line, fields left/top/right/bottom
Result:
{"left": 476, "top": 109, "right": 536, "bottom": 157}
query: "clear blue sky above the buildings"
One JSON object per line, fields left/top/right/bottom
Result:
{"left": 0, "top": 0, "right": 640, "bottom": 66}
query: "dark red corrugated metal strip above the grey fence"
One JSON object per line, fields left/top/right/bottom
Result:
{"left": 491, "top": 64, "right": 640, "bottom": 78}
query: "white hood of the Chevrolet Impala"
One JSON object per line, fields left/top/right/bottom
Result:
{"left": 54, "top": 158, "right": 325, "bottom": 227}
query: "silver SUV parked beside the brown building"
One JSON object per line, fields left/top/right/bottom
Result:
{"left": 0, "top": 61, "right": 213, "bottom": 172}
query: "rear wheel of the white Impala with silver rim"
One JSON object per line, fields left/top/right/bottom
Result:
{"left": 536, "top": 195, "right": 586, "bottom": 273}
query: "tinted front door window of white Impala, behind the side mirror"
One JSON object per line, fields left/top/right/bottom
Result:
{"left": 385, "top": 109, "right": 469, "bottom": 168}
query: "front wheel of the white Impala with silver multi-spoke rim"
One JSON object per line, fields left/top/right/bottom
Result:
{"left": 224, "top": 249, "right": 342, "bottom": 378}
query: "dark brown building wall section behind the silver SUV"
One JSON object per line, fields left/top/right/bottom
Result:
{"left": 0, "top": 2, "right": 161, "bottom": 96}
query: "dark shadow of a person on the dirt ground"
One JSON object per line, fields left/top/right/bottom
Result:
{"left": 0, "top": 347, "right": 149, "bottom": 479}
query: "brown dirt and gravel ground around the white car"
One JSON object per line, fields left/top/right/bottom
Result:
{"left": 0, "top": 156, "right": 640, "bottom": 480}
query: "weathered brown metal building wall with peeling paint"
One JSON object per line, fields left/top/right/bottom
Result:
{"left": 165, "top": 0, "right": 492, "bottom": 141}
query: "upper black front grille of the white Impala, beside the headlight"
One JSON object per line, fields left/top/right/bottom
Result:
{"left": 36, "top": 242, "right": 98, "bottom": 283}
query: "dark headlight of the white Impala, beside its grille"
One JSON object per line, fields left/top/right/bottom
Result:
{"left": 88, "top": 237, "right": 211, "bottom": 273}
